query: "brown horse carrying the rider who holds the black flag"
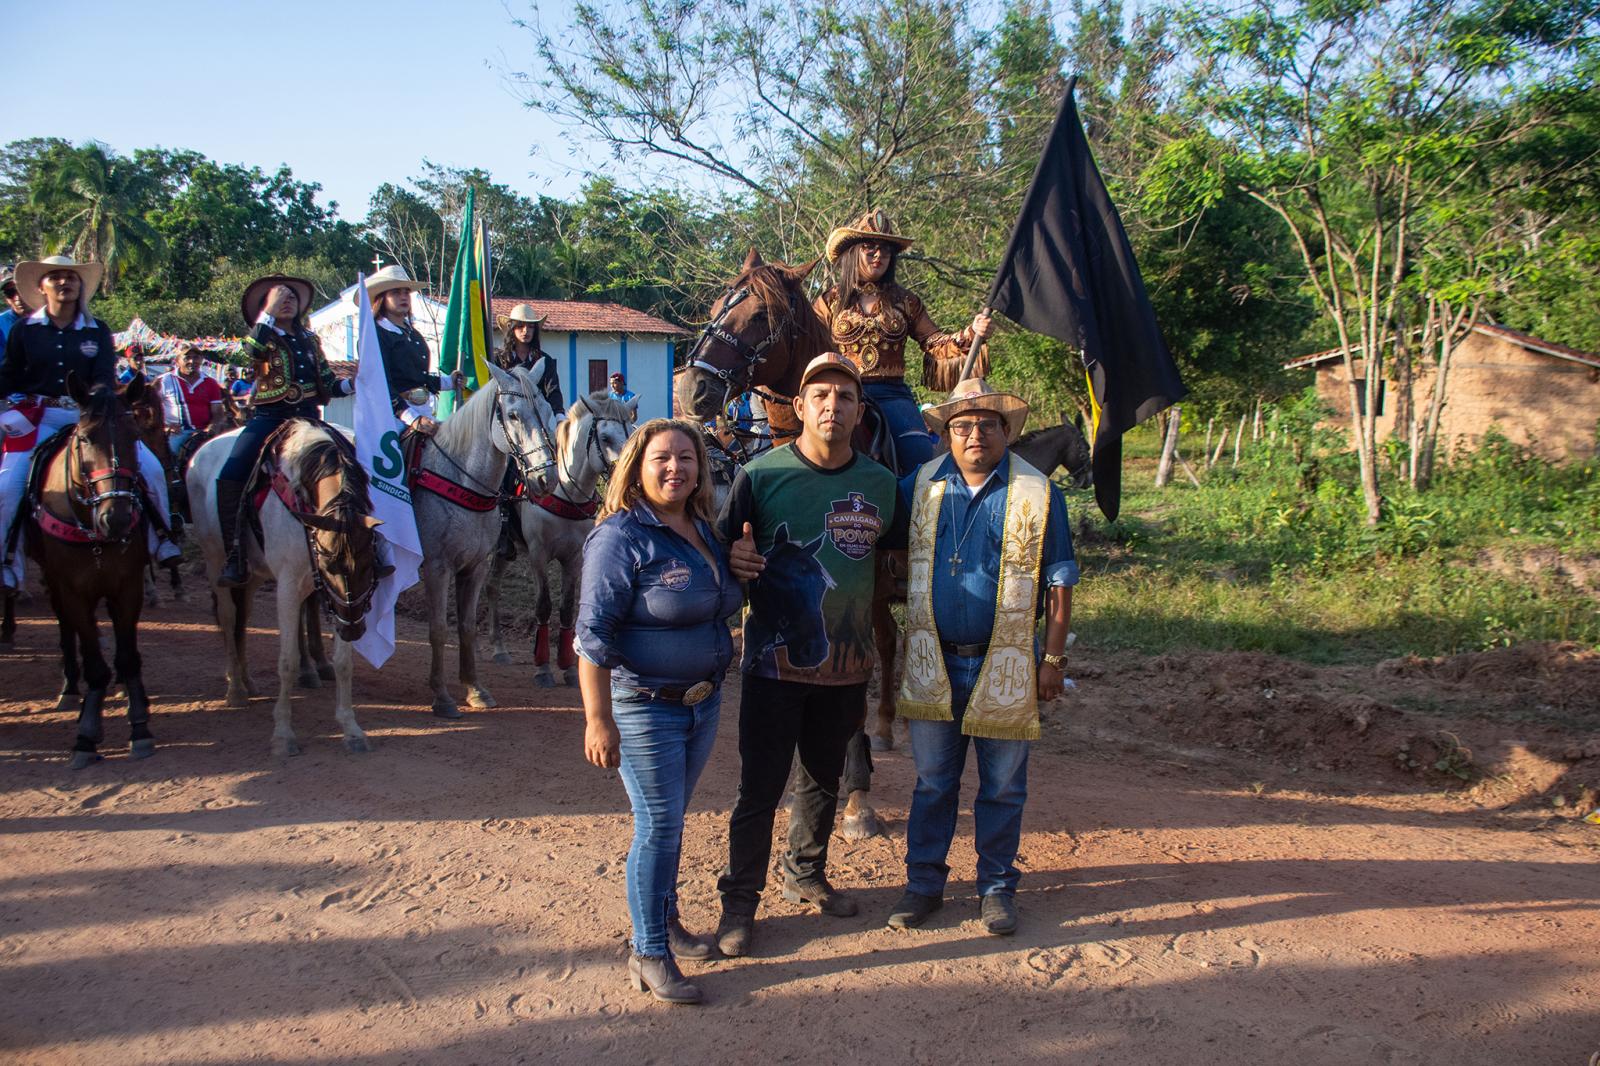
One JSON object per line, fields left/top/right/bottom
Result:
{"left": 674, "top": 248, "right": 904, "bottom": 839}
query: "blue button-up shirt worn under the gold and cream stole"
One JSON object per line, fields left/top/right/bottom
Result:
{"left": 896, "top": 451, "right": 1078, "bottom": 643}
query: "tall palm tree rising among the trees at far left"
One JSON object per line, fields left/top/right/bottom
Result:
{"left": 32, "top": 141, "right": 166, "bottom": 293}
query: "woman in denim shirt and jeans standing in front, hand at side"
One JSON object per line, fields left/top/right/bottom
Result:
{"left": 576, "top": 418, "right": 742, "bottom": 1004}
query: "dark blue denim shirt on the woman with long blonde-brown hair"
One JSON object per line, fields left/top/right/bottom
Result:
{"left": 573, "top": 501, "right": 744, "bottom": 688}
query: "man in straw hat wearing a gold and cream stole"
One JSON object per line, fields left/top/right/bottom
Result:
{"left": 888, "top": 378, "right": 1078, "bottom": 936}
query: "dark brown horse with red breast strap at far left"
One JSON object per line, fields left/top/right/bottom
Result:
{"left": 27, "top": 375, "right": 155, "bottom": 770}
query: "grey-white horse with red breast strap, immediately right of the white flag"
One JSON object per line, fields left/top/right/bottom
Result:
{"left": 411, "top": 367, "right": 555, "bottom": 719}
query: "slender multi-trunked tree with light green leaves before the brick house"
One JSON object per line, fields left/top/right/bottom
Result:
{"left": 1179, "top": 0, "right": 1595, "bottom": 523}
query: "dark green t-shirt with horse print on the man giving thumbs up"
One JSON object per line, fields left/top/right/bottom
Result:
{"left": 718, "top": 445, "right": 906, "bottom": 685}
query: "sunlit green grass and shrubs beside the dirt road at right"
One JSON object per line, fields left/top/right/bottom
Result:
{"left": 1069, "top": 385, "right": 1600, "bottom": 663}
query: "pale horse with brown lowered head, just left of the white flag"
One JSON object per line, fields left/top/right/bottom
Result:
{"left": 187, "top": 421, "right": 379, "bottom": 755}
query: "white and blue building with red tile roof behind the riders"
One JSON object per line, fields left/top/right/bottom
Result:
{"left": 310, "top": 285, "right": 688, "bottom": 423}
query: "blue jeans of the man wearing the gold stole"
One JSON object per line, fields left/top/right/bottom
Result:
{"left": 906, "top": 655, "right": 1032, "bottom": 898}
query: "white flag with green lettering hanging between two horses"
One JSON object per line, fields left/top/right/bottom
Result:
{"left": 354, "top": 274, "right": 422, "bottom": 666}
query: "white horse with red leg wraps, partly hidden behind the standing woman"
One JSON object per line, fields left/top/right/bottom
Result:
{"left": 490, "top": 391, "right": 638, "bottom": 687}
